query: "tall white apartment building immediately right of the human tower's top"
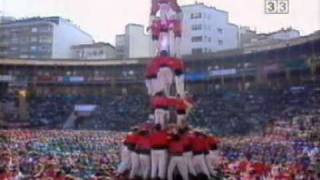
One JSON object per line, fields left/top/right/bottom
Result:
{"left": 181, "top": 3, "right": 239, "bottom": 55}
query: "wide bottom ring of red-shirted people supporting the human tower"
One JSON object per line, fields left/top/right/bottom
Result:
{"left": 114, "top": 123, "right": 224, "bottom": 180}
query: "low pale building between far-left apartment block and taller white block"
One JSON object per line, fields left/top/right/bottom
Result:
{"left": 72, "top": 42, "right": 116, "bottom": 60}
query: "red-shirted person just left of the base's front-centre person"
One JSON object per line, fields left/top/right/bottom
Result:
{"left": 136, "top": 129, "right": 151, "bottom": 179}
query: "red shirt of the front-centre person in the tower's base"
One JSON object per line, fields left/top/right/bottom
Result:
{"left": 150, "top": 131, "right": 171, "bottom": 149}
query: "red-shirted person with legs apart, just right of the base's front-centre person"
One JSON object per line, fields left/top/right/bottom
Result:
{"left": 168, "top": 131, "right": 189, "bottom": 180}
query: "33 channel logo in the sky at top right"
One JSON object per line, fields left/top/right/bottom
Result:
{"left": 264, "top": 0, "right": 289, "bottom": 14}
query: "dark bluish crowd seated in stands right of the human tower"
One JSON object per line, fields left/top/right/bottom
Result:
{"left": 188, "top": 86, "right": 320, "bottom": 135}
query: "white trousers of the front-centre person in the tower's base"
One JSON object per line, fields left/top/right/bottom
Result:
{"left": 151, "top": 150, "right": 168, "bottom": 179}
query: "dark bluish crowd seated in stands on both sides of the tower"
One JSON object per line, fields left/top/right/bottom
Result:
{"left": 0, "top": 87, "right": 320, "bottom": 135}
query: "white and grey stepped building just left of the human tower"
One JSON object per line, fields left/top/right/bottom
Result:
{"left": 116, "top": 24, "right": 153, "bottom": 58}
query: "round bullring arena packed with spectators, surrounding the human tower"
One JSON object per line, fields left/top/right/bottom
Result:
{"left": 0, "top": 30, "right": 320, "bottom": 179}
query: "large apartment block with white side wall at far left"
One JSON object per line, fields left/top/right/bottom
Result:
{"left": 0, "top": 17, "right": 93, "bottom": 59}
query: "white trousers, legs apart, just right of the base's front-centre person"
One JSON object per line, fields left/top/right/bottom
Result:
{"left": 168, "top": 156, "right": 189, "bottom": 180}
